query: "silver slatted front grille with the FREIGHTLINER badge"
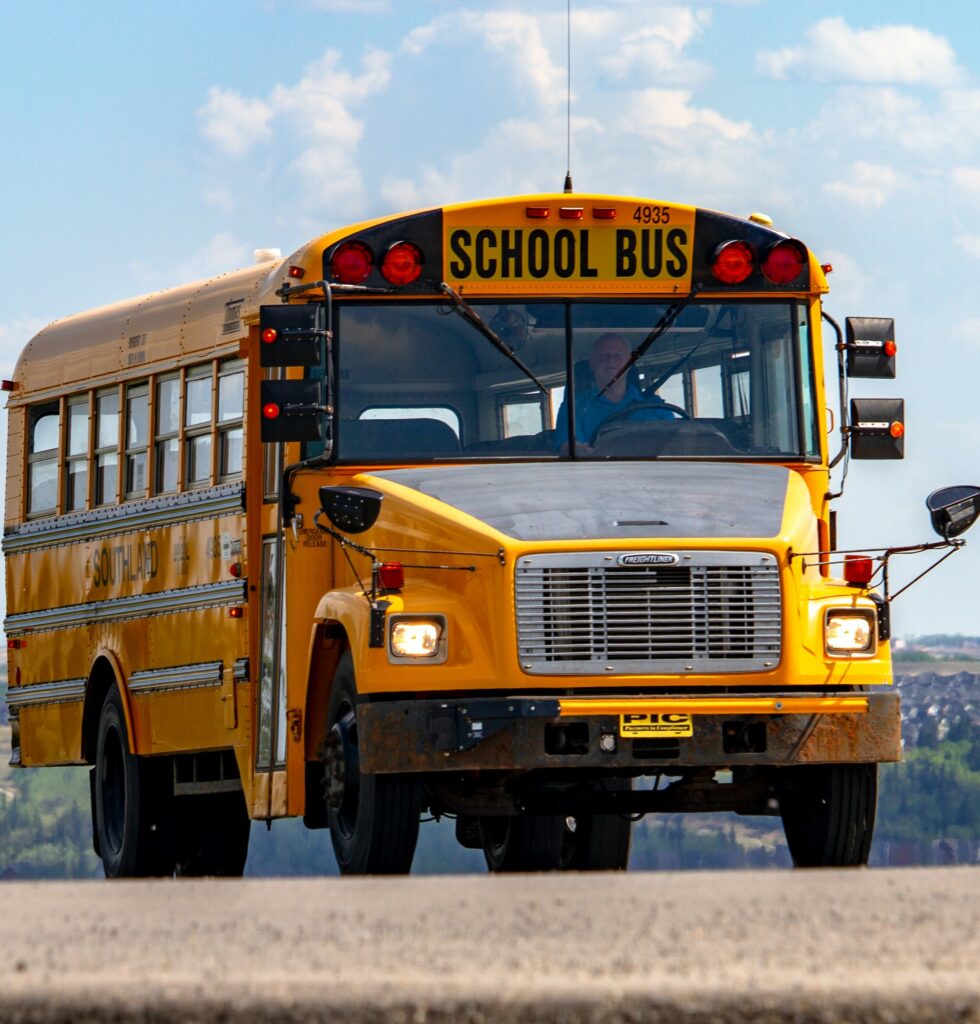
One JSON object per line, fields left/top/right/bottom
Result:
{"left": 515, "top": 552, "right": 780, "bottom": 675}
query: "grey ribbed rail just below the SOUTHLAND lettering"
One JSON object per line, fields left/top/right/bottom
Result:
{"left": 3, "top": 580, "right": 247, "bottom": 637}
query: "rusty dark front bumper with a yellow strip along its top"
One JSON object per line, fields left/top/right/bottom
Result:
{"left": 357, "top": 692, "right": 901, "bottom": 774}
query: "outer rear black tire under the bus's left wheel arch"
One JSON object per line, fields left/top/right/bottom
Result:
{"left": 92, "top": 685, "right": 174, "bottom": 879}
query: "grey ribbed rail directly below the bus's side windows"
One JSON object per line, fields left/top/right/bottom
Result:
{"left": 3, "top": 483, "right": 245, "bottom": 556}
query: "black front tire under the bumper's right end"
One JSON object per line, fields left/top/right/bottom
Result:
{"left": 776, "top": 764, "right": 878, "bottom": 867}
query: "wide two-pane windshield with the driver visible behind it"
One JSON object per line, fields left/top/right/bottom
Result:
{"left": 334, "top": 301, "right": 819, "bottom": 462}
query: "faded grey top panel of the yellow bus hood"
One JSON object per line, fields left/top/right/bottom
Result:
{"left": 365, "top": 462, "right": 794, "bottom": 542}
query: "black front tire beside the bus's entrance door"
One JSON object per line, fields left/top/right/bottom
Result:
{"left": 324, "top": 652, "right": 422, "bottom": 874}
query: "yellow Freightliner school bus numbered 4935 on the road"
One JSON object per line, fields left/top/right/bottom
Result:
{"left": 3, "top": 194, "right": 980, "bottom": 877}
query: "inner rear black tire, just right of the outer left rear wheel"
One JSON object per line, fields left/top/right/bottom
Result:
{"left": 174, "top": 793, "right": 252, "bottom": 879}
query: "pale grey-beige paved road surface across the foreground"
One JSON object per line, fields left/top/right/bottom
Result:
{"left": 0, "top": 867, "right": 980, "bottom": 1024}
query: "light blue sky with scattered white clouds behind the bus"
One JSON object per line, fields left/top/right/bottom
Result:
{"left": 0, "top": 0, "right": 980, "bottom": 635}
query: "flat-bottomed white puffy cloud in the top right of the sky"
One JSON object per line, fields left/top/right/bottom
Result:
{"left": 757, "top": 16, "right": 962, "bottom": 87}
